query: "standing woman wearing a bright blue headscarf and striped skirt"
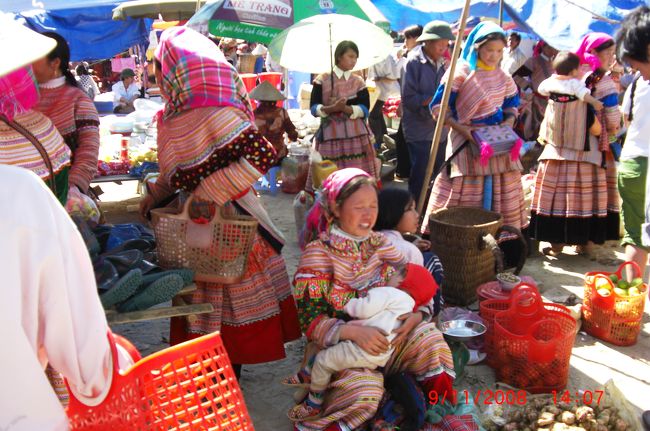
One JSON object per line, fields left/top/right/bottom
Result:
{"left": 422, "top": 21, "right": 528, "bottom": 241}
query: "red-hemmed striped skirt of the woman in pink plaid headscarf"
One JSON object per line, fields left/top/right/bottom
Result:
{"left": 172, "top": 235, "right": 302, "bottom": 364}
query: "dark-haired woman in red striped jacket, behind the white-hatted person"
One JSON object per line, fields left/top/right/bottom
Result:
{"left": 33, "top": 32, "right": 99, "bottom": 193}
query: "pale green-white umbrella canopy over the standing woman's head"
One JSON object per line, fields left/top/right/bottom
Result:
{"left": 269, "top": 13, "right": 393, "bottom": 73}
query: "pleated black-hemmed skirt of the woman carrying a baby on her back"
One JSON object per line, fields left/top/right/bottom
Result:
{"left": 530, "top": 160, "right": 620, "bottom": 245}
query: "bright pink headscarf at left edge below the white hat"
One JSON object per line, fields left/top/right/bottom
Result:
{"left": 0, "top": 66, "right": 38, "bottom": 120}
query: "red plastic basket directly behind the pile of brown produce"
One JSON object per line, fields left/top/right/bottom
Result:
{"left": 493, "top": 289, "right": 576, "bottom": 393}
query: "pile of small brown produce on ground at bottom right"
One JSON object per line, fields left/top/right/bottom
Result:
{"left": 483, "top": 393, "right": 632, "bottom": 431}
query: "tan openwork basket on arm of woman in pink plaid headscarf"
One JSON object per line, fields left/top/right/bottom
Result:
{"left": 151, "top": 199, "right": 257, "bottom": 284}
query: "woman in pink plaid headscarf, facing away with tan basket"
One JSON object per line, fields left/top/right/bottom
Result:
{"left": 141, "top": 27, "right": 300, "bottom": 369}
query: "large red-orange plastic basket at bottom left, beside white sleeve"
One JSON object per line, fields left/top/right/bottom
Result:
{"left": 67, "top": 332, "right": 254, "bottom": 431}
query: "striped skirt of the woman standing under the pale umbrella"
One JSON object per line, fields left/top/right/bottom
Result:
{"left": 305, "top": 135, "right": 381, "bottom": 191}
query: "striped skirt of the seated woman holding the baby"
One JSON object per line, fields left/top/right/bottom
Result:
{"left": 296, "top": 323, "right": 455, "bottom": 431}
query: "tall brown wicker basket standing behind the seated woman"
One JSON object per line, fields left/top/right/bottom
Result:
{"left": 429, "top": 207, "right": 525, "bottom": 305}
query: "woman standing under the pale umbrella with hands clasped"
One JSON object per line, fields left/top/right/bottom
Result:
{"left": 306, "top": 40, "right": 379, "bottom": 190}
